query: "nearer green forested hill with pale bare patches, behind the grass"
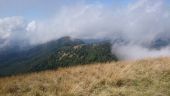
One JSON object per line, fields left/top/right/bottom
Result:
{"left": 34, "top": 42, "right": 117, "bottom": 71}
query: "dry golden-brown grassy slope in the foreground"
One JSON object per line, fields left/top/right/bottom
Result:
{"left": 0, "top": 58, "right": 170, "bottom": 96}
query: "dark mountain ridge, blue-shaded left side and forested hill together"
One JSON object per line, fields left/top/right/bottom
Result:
{"left": 0, "top": 37, "right": 117, "bottom": 76}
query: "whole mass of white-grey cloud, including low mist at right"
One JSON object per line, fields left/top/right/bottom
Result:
{"left": 0, "top": 0, "right": 170, "bottom": 59}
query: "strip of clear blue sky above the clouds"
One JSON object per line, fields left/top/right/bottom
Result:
{"left": 0, "top": 0, "right": 135, "bottom": 20}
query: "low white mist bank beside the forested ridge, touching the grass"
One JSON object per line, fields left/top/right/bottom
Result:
{"left": 112, "top": 44, "right": 170, "bottom": 60}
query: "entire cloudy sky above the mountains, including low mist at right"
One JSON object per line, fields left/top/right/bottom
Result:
{"left": 0, "top": 0, "right": 170, "bottom": 59}
